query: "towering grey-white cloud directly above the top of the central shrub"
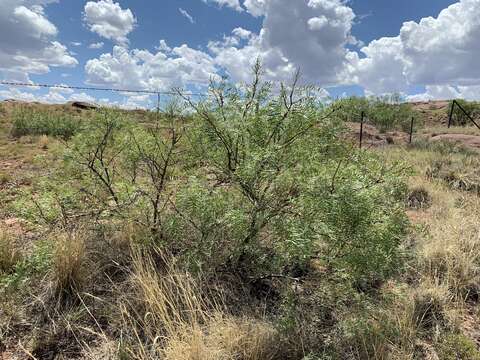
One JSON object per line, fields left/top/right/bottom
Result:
{"left": 209, "top": 0, "right": 355, "bottom": 85}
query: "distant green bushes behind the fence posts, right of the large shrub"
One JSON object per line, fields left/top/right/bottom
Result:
{"left": 335, "top": 95, "right": 421, "bottom": 132}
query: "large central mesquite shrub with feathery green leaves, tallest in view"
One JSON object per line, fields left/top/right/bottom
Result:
{"left": 170, "top": 65, "right": 406, "bottom": 280}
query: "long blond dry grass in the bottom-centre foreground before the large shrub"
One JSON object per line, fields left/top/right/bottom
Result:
{"left": 120, "top": 250, "right": 280, "bottom": 360}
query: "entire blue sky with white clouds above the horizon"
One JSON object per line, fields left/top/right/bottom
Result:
{"left": 0, "top": 0, "right": 480, "bottom": 107}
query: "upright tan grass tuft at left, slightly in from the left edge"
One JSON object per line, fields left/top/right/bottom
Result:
{"left": 53, "top": 229, "right": 86, "bottom": 300}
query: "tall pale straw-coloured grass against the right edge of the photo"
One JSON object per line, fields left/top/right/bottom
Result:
{"left": 410, "top": 177, "right": 480, "bottom": 301}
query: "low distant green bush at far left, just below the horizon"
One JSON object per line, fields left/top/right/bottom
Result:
{"left": 11, "top": 107, "right": 82, "bottom": 140}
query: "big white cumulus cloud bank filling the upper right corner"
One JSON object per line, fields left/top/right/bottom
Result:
{"left": 349, "top": 0, "right": 480, "bottom": 97}
